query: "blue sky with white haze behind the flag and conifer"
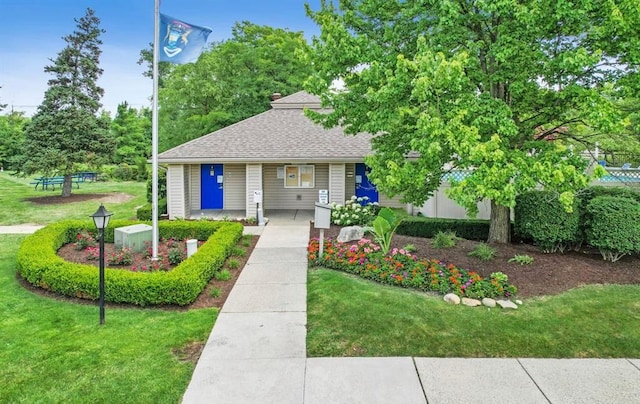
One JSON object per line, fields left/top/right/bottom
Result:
{"left": 0, "top": 0, "right": 320, "bottom": 115}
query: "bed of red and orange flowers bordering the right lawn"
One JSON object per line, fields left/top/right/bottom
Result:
{"left": 307, "top": 238, "right": 517, "bottom": 298}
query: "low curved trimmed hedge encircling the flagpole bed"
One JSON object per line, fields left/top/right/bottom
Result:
{"left": 17, "top": 220, "right": 243, "bottom": 306}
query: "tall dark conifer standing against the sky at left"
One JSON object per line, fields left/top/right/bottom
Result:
{"left": 22, "top": 9, "right": 114, "bottom": 197}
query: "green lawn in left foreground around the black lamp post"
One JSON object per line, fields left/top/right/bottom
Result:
{"left": 0, "top": 235, "right": 217, "bottom": 403}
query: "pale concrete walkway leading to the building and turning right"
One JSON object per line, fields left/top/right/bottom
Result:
{"left": 183, "top": 215, "right": 640, "bottom": 404}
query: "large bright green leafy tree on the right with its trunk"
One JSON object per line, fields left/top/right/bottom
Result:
{"left": 306, "top": 0, "right": 640, "bottom": 242}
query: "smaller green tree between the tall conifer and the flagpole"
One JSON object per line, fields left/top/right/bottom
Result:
{"left": 111, "top": 101, "right": 151, "bottom": 165}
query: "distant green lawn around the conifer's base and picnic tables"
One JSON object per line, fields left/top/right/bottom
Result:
{"left": 0, "top": 171, "right": 146, "bottom": 226}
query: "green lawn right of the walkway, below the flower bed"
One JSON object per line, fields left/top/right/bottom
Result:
{"left": 307, "top": 269, "right": 640, "bottom": 358}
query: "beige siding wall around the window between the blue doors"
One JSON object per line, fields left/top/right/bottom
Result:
{"left": 262, "top": 163, "right": 329, "bottom": 211}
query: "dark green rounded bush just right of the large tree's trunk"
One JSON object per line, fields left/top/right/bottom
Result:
{"left": 514, "top": 191, "right": 582, "bottom": 252}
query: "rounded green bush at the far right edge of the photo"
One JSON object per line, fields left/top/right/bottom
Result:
{"left": 585, "top": 196, "right": 640, "bottom": 262}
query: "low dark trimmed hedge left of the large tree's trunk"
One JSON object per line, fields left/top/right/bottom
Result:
{"left": 396, "top": 216, "right": 489, "bottom": 240}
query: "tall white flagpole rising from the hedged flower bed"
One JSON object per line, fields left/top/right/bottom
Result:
{"left": 151, "top": 0, "right": 160, "bottom": 260}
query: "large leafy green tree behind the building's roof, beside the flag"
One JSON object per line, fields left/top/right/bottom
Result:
{"left": 156, "top": 22, "right": 311, "bottom": 150}
